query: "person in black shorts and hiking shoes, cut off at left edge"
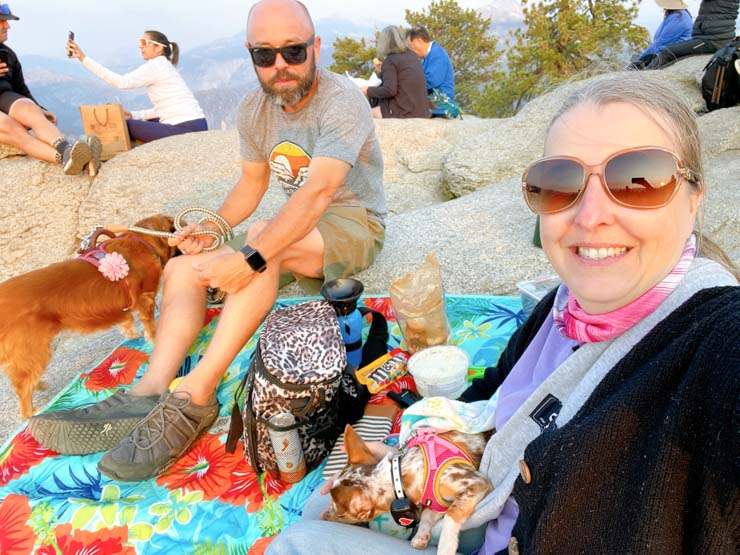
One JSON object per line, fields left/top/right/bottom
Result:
{"left": 0, "top": 4, "right": 95, "bottom": 175}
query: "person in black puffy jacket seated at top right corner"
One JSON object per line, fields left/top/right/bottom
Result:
{"left": 646, "top": 0, "right": 740, "bottom": 69}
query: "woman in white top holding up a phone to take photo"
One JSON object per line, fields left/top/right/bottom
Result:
{"left": 67, "top": 31, "right": 208, "bottom": 143}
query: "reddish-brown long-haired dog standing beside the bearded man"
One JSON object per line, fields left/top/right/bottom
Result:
{"left": 0, "top": 215, "right": 175, "bottom": 418}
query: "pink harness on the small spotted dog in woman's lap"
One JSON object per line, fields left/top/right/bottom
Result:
{"left": 406, "top": 428, "right": 475, "bottom": 513}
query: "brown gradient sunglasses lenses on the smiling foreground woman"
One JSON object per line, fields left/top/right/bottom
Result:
{"left": 524, "top": 149, "right": 678, "bottom": 214}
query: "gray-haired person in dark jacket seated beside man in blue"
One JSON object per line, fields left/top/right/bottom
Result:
{"left": 362, "top": 25, "right": 431, "bottom": 118}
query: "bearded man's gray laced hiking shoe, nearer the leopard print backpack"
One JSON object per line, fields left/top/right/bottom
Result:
{"left": 98, "top": 392, "right": 218, "bottom": 482}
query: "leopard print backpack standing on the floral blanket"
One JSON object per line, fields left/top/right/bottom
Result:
{"left": 226, "top": 300, "right": 351, "bottom": 473}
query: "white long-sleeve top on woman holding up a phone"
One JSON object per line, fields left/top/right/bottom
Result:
{"left": 82, "top": 56, "right": 205, "bottom": 125}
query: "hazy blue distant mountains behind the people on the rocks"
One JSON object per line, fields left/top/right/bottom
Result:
{"left": 18, "top": 11, "right": 521, "bottom": 135}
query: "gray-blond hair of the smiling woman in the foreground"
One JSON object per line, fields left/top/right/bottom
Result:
{"left": 548, "top": 71, "right": 740, "bottom": 280}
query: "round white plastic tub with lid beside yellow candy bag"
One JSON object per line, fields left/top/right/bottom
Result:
{"left": 408, "top": 345, "right": 470, "bottom": 399}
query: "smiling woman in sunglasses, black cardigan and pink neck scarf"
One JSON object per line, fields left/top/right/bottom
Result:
{"left": 267, "top": 72, "right": 740, "bottom": 555}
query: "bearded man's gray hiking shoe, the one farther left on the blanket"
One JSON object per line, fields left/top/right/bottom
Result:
{"left": 28, "top": 389, "right": 159, "bottom": 455}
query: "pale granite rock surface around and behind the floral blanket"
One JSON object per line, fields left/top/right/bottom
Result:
{"left": 0, "top": 56, "right": 740, "bottom": 446}
